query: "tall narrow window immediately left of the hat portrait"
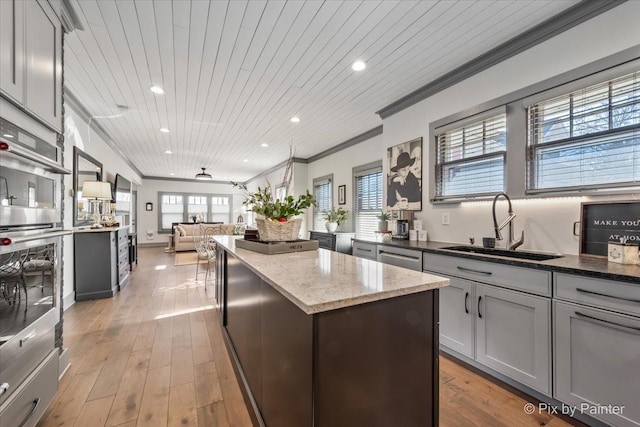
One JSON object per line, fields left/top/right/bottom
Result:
{"left": 353, "top": 161, "right": 382, "bottom": 239}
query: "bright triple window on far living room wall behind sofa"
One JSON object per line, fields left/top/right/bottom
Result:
{"left": 158, "top": 193, "right": 232, "bottom": 231}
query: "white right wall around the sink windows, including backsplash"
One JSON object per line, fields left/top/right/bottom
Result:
{"left": 380, "top": 1, "right": 640, "bottom": 254}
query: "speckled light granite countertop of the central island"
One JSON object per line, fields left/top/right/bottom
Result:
{"left": 215, "top": 236, "right": 449, "bottom": 314}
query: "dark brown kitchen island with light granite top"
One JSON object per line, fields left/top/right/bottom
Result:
{"left": 215, "top": 236, "right": 449, "bottom": 427}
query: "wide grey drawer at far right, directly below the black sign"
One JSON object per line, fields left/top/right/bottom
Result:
{"left": 554, "top": 273, "right": 640, "bottom": 316}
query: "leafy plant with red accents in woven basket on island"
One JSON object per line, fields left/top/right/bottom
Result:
{"left": 231, "top": 181, "right": 316, "bottom": 242}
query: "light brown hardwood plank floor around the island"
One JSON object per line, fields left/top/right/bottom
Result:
{"left": 38, "top": 248, "right": 571, "bottom": 427}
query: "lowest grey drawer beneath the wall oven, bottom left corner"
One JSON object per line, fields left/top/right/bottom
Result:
{"left": 0, "top": 350, "right": 58, "bottom": 427}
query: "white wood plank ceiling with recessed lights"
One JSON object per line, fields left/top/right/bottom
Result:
{"left": 64, "top": 0, "right": 577, "bottom": 181}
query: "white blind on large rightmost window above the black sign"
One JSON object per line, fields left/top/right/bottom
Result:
{"left": 527, "top": 72, "right": 640, "bottom": 192}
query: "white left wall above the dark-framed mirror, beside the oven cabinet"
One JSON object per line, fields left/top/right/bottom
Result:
{"left": 62, "top": 104, "right": 142, "bottom": 310}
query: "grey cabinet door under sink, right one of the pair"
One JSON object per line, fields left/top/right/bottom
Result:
{"left": 475, "top": 284, "right": 551, "bottom": 395}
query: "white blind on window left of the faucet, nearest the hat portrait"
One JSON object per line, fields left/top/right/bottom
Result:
{"left": 435, "top": 113, "right": 507, "bottom": 200}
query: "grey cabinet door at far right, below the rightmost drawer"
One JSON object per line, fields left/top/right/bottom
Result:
{"left": 554, "top": 301, "right": 640, "bottom": 427}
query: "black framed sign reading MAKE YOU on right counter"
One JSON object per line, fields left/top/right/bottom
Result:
{"left": 580, "top": 200, "right": 640, "bottom": 258}
